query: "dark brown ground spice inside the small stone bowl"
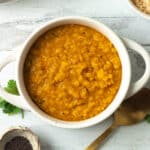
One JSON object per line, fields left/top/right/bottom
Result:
{"left": 4, "top": 136, "right": 33, "bottom": 150}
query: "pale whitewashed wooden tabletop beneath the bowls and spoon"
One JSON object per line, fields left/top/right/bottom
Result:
{"left": 0, "top": 0, "right": 150, "bottom": 150}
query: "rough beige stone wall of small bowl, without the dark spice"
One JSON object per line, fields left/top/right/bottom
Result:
{"left": 0, "top": 126, "right": 41, "bottom": 150}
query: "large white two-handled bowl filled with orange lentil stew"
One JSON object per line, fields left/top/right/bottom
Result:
{"left": 0, "top": 17, "right": 150, "bottom": 128}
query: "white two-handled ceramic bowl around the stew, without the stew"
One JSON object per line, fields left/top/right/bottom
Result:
{"left": 0, "top": 16, "right": 150, "bottom": 128}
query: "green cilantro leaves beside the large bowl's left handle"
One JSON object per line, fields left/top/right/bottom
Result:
{"left": 0, "top": 80, "right": 24, "bottom": 118}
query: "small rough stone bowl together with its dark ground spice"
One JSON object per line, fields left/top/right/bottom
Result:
{"left": 0, "top": 127, "right": 40, "bottom": 150}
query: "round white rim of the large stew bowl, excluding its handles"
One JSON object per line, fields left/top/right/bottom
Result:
{"left": 16, "top": 16, "right": 131, "bottom": 129}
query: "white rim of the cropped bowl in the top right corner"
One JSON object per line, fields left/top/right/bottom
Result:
{"left": 127, "top": 0, "right": 150, "bottom": 20}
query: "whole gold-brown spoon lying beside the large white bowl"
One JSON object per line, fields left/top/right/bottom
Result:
{"left": 86, "top": 88, "right": 150, "bottom": 150}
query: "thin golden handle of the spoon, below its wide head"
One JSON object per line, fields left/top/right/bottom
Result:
{"left": 85, "top": 123, "right": 118, "bottom": 150}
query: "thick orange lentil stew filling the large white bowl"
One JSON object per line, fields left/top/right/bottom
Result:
{"left": 24, "top": 24, "right": 122, "bottom": 121}
